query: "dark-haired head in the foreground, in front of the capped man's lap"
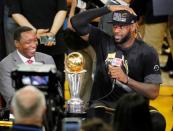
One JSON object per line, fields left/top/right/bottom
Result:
{"left": 113, "top": 93, "right": 152, "bottom": 131}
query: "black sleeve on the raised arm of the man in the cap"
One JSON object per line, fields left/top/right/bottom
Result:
{"left": 70, "top": 7, "right": 110, "bottom": 36}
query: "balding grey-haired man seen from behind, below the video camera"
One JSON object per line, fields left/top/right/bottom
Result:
{"left": 10, "top": 86, "right": 46, "bottom": 131}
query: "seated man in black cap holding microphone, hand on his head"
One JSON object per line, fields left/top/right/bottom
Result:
{"left": 68, "top": 5, "right": 162, "bottom": 108}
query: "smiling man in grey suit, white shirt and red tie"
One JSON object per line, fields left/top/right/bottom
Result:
{"left": 0, "top": 26, "right": 55, "bottom": 107}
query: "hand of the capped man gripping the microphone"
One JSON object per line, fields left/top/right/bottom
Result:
{"left": 108, "top": 65, "right": 128, "bottom": 83}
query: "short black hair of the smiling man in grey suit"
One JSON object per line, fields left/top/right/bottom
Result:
{"left": 13, "top": 26, "right": 33, "bottom": 41}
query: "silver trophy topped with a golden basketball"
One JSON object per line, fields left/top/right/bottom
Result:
{"left": 65, "top": 52, "right": 86, "bottom": 114}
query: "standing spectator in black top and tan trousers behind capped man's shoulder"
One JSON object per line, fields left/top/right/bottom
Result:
{"left": 143, "top": 0, "right": 170, "bottom": 54}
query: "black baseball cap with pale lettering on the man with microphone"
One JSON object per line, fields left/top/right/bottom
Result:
{"left": 108, "top": 10, "right": 137, "bottom": 26}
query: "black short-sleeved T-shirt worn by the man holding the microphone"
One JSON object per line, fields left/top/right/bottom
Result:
{"left": 89, "top": 28, "right": 162, "bottom": 107}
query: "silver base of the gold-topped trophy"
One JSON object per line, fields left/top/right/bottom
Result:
{"left": 67, "top": 98, "right": 84, "bottom": 114}
